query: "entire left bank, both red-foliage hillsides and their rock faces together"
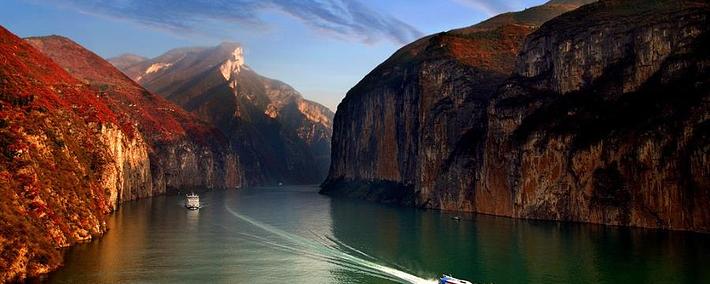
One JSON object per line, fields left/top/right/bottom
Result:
{"left": 0, "top": 28, "right": 242, "bottom": 282}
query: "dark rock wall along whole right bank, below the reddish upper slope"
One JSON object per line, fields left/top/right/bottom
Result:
{"left": 323, "top": 1, "right": 710, "bottom": 231}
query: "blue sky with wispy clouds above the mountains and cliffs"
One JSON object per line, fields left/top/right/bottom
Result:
{"left": 0, "top": 0, "right": 545, "bottom": 110}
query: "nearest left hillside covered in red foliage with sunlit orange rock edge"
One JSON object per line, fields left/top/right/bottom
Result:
{"left": 0, "top": 27, "right": 131, "bottom": 282}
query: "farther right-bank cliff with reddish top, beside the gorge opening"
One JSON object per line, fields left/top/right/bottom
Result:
{"left": 323, "top": 1, "right": 591, "bottom": 204}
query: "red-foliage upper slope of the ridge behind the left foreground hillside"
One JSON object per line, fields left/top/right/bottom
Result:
{"left": 27, "top": 36, "right": 227, "bottom": 144}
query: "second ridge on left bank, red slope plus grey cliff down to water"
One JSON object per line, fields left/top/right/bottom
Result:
{"left": 27, "top": 36, "right": 241, "bottom": 195}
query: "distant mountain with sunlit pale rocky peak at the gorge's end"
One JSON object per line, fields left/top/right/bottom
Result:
{"left": 110, "top": 43, "right": 333, "bottom": 184}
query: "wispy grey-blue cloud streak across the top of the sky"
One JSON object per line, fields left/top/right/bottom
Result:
{"left": 47, "top": 0, "right": 423, "bottom": 44}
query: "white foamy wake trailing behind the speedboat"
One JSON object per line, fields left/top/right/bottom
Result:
{"left": 225, "top": 206, "right": 437, "bottom": 284}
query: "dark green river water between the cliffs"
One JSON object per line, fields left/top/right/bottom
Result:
{"left": 45, "top": 187, "right": 710, "bottom": 283}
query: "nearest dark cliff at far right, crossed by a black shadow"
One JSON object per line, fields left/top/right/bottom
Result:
{"left": 486, "top": 1, "right": 710, "bottom": 231}
